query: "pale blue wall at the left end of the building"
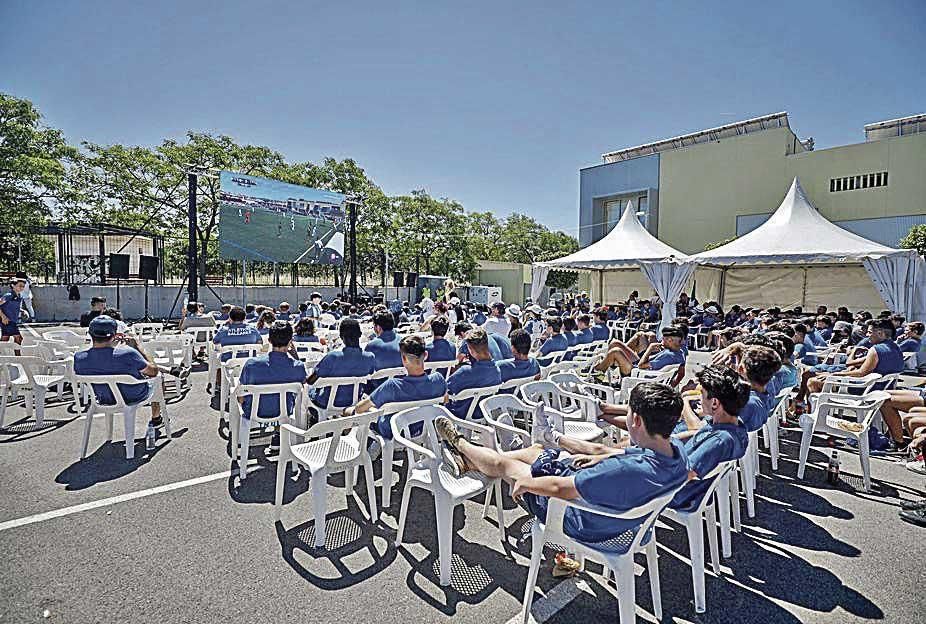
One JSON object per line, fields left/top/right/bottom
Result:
{"left": 579, "top": 154, "right": 659, "bottom": 247}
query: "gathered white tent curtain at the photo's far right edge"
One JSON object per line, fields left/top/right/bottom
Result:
{"left": 862, "top": 252, "right": 926, "bottom": 320}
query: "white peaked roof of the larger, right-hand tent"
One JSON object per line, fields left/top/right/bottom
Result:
{"left": 691, "top": 178, "right": 913, "bottom": 266}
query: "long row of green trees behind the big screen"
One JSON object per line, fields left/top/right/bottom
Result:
{"left": 0, "top": 94, "right": 578, "bottom": 287}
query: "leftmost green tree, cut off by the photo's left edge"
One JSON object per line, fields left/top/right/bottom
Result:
{"left": 0, "top": 93, "right": 79, "bottom": 273}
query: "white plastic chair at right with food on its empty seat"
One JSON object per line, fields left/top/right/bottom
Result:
{"left": 797, "top": 390, "right": 891, "bottom": 491}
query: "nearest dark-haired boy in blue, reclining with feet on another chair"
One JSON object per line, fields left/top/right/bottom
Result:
{"left": 434, "top": 383, "right": 688, "bottom": 544}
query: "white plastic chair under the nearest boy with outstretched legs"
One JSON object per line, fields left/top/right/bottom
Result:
{"left": 521, "top": 486, "right": 681, "bottom": 624}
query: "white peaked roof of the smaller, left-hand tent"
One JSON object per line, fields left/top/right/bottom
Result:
{"left": 538, "top": 201, "right": 686, "bottom": 269}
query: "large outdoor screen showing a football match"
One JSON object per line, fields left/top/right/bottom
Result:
{"left": 219, "top": 171, "right": 347, "bottom": 264}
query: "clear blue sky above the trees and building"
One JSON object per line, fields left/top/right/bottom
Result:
{"left": 0, "top": 0, "right": 926, "bottom": 234}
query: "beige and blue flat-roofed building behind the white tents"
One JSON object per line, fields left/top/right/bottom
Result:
{"left": 579, "top": 112, "right": 926, "bottom": 253}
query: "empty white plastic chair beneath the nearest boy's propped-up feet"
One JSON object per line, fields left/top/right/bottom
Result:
{"left": 390, "top": 405, "right": 505, "bottom": 586}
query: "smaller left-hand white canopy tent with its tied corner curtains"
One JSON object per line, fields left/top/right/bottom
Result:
{"left": 531, "top": 201, "right": 696, "bottom": 334}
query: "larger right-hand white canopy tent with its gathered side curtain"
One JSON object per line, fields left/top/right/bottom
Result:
{"left": 689, "top": 178, "right": 926, "bottom": 319}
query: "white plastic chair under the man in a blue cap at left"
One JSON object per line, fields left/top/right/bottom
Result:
{"left": 74, "top": 374, "right": 171, "bottom": 459}
